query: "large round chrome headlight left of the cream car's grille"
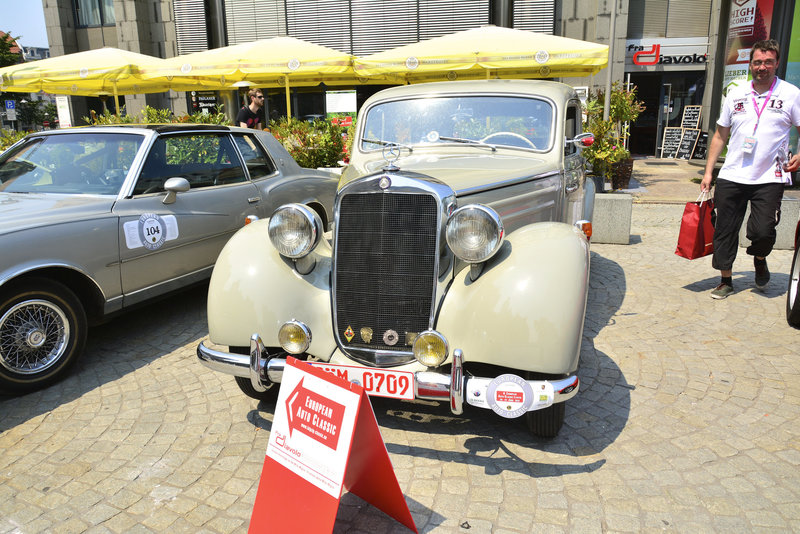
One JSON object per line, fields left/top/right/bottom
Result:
{"left": 269, "top": 204, "right": 322, "bottom": 259}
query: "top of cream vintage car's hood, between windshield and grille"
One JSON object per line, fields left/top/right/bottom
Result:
{"left": 340, "top": 150, "right": 556, "bottom": 192}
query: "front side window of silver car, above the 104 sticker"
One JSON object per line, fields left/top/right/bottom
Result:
{"left": 133, "top": 133, "right": 247, "bottom": 195}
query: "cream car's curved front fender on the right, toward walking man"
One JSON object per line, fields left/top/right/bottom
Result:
{"left": 436, "top": 223, "right": 589, "bottom": 374}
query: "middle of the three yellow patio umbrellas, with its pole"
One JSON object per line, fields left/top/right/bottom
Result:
{"left": 138, "top": 37, "right": 362, "bottom": 115}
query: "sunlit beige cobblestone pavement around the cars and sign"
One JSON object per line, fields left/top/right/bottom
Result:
{"left": 0, "top": 204, "right": 800, "bottom": 534}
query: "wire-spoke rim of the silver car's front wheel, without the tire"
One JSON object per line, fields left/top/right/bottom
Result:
{"left": 0, "top": 299, "right": 70, "bottom": 374}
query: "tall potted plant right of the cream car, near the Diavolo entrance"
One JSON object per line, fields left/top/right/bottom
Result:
{"left": 583, "top": 82, "right": 644, "bottom": 189}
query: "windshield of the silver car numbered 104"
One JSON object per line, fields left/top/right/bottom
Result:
{"left": 0, "top": 131, "right": 143, "bottom": 195}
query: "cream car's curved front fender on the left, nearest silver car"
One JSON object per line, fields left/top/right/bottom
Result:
{"left": 208, "top": 219, "right": 336, "bottom": 358}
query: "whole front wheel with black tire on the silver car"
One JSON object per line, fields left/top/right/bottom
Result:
{"left": 0, "top": 278, "right": 87, "bottom": 394}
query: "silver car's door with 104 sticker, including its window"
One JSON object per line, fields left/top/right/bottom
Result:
{"left": 114, "top": 131, "right": 262, "bottom": 306}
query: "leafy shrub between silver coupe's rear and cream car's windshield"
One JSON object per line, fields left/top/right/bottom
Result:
{"left": 269, "top": 118, "right": 354, "bottom": 169}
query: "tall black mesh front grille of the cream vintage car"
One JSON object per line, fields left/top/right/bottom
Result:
{"left": 333, "top": 192, "right": 439, "bottom": 365}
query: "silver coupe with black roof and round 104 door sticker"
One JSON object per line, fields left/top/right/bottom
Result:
{"left": 0, "top": 125, "right": 337, "bottom": 394}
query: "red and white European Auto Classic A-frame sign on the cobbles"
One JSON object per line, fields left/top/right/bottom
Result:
{"left": 249, "top": 357, "right": 417, "bottom": 533}
